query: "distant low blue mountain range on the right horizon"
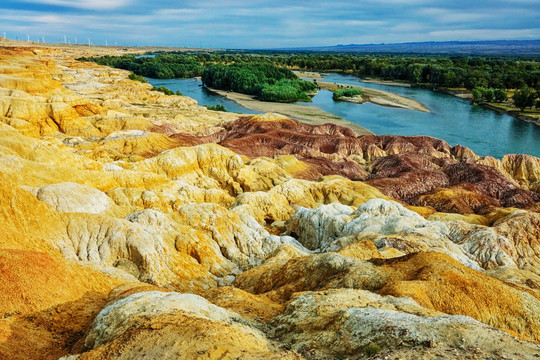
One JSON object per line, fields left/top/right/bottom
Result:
{"left": 276, "top": 40, "right": 540, "bottom": 55}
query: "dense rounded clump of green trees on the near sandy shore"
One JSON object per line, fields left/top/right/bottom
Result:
{"left": 201, "top": 62, "right": 317, "bottom": 102}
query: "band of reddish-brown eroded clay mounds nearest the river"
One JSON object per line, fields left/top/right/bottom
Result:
{"left": 169, "top": 115, "right": 540, "bottom": 214}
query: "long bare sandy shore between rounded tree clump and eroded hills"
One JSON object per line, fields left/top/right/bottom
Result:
{"left": 208, "top": 88, "right": 373, "bottom": 135}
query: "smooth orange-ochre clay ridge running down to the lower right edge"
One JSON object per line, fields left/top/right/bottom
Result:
{"left": 234, "top": 252, "right": 540, "bottom": 342}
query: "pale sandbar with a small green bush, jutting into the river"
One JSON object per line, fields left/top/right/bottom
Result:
{"left": 317, "top": 81, "right": 430, "bottom": 112}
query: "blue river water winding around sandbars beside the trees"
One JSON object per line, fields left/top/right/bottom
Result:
{"left": 148, "top": 73, "right": 540, "bottom": 158}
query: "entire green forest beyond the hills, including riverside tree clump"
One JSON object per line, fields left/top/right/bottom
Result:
{"left": 81, "top": 51, "right": 540, "bottom": 105}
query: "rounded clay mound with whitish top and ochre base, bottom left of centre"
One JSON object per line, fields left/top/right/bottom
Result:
{"left": 71, "top": 291, "right": 300, "bottom": 360}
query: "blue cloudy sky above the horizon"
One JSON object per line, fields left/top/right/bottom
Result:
{"left": 0, "top": 0, "right": 540, "bottom": 48}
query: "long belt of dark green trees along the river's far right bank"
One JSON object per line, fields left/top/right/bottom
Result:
{"left": 262, "top": 53, "right": 540, "bottom": 89}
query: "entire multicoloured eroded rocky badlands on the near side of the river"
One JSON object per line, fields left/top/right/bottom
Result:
{"left": 0, "top": 43, "right": 540, "bottom": 360}
